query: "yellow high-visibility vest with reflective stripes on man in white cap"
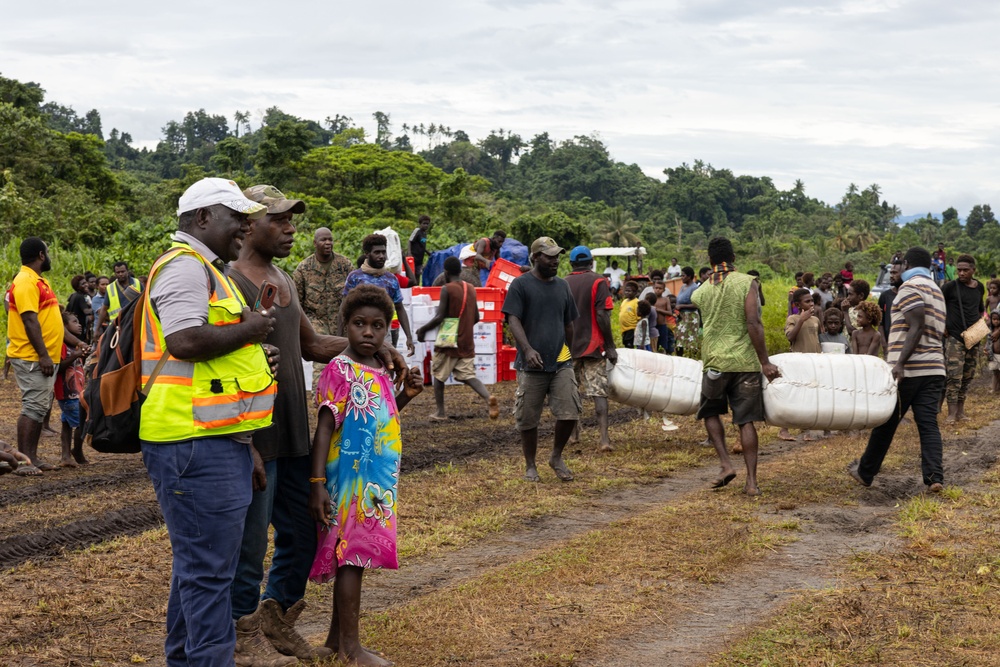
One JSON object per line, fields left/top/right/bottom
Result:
{"left": 139, "top": 243, "right": 278, "bottom": 443}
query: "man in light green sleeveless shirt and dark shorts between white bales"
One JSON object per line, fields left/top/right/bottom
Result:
{"left": 691, "top": 237, "right": 781, "bottom": 496}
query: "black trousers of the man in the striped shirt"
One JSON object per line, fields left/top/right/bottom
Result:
{"left": 858, "top": 375, "right": 945, "bottom": 486}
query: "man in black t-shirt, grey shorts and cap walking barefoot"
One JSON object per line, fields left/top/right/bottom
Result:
{"left": 503, "top": 236, "right": 582, "bottom": 482}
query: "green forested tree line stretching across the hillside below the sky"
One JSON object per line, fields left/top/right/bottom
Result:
{"left": 0, "top": 76, "right": 1000, "bottom": 294}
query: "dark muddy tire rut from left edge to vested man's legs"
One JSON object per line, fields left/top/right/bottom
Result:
{"left": 0, "top": 503, "right": 163, "bottom": 570}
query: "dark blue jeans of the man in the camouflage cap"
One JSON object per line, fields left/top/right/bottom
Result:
{"left": 232, "top": 456, "right": 316, "bottom": 619}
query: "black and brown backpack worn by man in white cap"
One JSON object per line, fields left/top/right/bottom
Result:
{"left": 83, "top": 286, "right": 170, "bottom": 454}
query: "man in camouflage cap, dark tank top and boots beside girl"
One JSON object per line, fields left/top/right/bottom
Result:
{"left": 231, "top": 185, "right": 405, "bottom": 667}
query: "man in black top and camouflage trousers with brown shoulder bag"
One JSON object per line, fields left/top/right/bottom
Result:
{"left": 941, "top": 255, "right": 986, "bottom": 423}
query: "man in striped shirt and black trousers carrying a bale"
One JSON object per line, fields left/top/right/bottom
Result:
{"left": 849, "top": 248, "right": 946, "bottom": 493}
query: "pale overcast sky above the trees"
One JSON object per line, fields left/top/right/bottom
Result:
{"left": 7, "top": 0, "right": 1000, "bottom": 217}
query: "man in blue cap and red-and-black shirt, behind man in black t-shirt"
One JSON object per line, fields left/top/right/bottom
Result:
{"left": 566, "top": 245, "right": 618, "bottom": 452}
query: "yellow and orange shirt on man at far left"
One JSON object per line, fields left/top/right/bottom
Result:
{"left": 7, "top": 266, "right": 63, "bottom": 363}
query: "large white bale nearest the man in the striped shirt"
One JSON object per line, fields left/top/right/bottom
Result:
{"left": 764, "top": 353, "right": 896, "bottom": 431}
